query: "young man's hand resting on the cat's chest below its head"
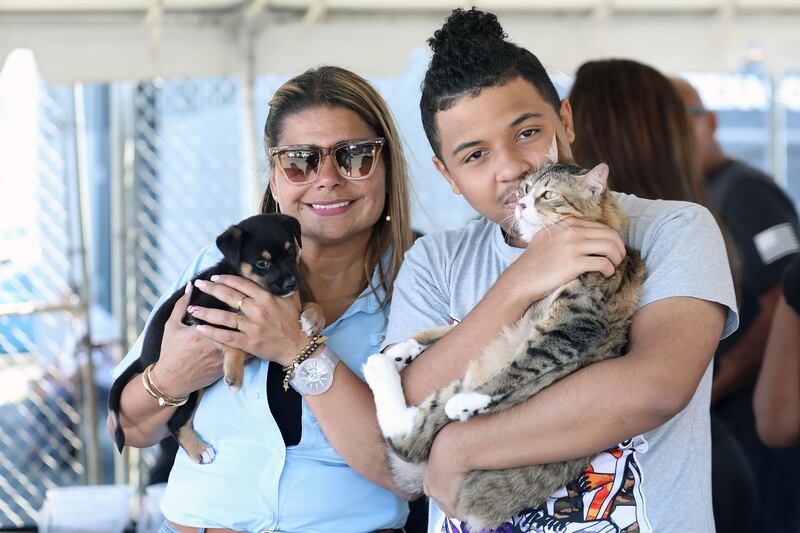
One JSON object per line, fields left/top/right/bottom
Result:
{"left": 500, "top": 218, "right": 626, "bottom": 305}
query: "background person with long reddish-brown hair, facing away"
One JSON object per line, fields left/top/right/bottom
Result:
{"left": 569, "top": 59, "right": 756, "bottom": 533}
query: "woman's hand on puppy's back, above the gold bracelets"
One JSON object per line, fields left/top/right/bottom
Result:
{"left": 150, "top": 284, "right": 222, "bottom": 398}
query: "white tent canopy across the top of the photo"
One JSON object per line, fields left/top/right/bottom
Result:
{"left": 0, "top": 0, "right": 800, "bottom": 83}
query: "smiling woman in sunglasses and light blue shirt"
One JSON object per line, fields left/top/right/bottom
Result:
{"left": 109, "top": 67, "right": 411, "bottom": 533}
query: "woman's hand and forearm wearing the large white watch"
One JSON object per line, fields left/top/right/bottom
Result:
{"left": 189, "top": 276, "right": 408, "bottom": 498}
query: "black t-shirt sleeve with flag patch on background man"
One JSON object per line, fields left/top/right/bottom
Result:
{"left": 720, "top": 178, "right": 800, "bottom": 296}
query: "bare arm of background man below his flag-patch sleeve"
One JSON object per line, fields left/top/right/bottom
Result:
{"left": 711, "top": 284, "right": 781, "bottom": 402}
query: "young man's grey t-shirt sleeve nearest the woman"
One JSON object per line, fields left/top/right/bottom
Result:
{"left": 381, "top": 237, "right": 450, "bottom": 348}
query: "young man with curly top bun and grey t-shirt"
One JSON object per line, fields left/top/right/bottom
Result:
{"left": 385, "top": 10, "right": 737, "bottom": 532}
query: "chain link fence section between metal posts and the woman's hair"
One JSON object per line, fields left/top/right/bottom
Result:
{"left": 123, "top": 78, "right": 249, "bottom": 483}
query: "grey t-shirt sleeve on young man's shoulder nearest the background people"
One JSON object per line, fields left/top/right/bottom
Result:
{"left": 639, "top": 204, "right": 739, "bottom": 338}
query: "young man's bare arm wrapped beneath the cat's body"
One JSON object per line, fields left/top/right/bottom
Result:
{"left": 425, "top": 297, "right": 725, "bottom": 516}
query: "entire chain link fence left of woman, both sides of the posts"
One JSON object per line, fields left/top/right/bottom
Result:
{"left": 0, "top": 68, "right": 250, "bottom": 528}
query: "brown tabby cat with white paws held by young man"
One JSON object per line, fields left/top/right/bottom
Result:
{"left": 364, "top": 143, "right": 645, "bottom": 531}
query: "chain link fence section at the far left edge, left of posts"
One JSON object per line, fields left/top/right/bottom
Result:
{"left": 0, "top": 78, "right": 86, "bottom": 527}
